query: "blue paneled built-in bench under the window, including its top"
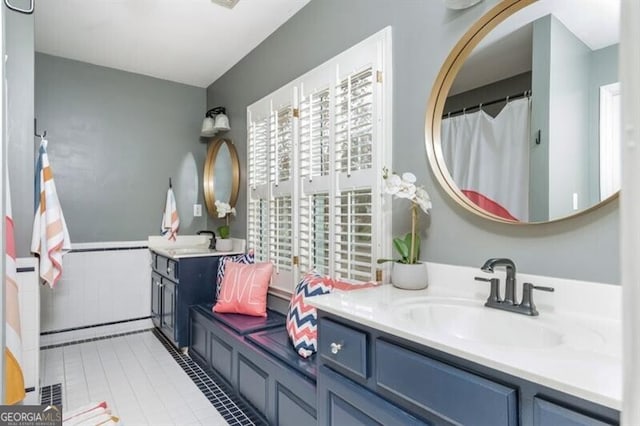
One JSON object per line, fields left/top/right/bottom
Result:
{"left": 189, "top": 305, "right": 316, "bottom": 425}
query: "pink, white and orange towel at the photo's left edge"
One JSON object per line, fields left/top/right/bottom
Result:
{"left": 4, "top": 166, "right": 25, "bottom": 404}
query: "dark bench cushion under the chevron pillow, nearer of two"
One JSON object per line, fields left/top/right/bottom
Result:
{"left": 245, "top": 327, "right": 317, "bottom": 382}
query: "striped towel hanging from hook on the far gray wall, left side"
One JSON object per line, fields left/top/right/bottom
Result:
{"left": 31, "top": 139, "right": 71, "bottom": 287}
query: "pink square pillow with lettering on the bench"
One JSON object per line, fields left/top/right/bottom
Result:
{"left": 213, "top": 262, "right": 273, "bottom": 317}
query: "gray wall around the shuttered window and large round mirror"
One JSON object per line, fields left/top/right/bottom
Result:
{"left": 207, "top": 0, "right": 620, "bottom": 286}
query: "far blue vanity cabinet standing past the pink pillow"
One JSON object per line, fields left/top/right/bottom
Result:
{"left": 151, "top": 250, "right": 219, "bottom": 348}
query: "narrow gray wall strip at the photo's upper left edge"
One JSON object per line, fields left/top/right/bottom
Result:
{"left": 3, "top": 1, "right": 35, "bottom": 257}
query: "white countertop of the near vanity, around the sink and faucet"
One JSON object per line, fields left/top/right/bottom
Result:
{"left": 309, "top": 263, "right": 622, "bottom": 410}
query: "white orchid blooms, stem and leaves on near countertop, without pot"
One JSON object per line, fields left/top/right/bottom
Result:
{"left": 378, "top": 167, "right": 431, "bottom": 264}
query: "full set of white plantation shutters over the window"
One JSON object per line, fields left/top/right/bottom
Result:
{"left": 247, "top": 25, "right": 391, "bottom": 293}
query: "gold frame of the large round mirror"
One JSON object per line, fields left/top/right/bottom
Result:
{"left": 425, "top": 0, "right": 620, "bottom": 225}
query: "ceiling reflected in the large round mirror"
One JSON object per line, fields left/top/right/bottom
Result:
{"left": 450, "top": 0, "right": 620, "bottom": 95}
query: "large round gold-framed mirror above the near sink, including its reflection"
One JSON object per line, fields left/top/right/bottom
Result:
{"left": 425, "top": 0, "right": 619, "bottom": 225}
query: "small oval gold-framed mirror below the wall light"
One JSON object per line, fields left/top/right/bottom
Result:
{"left": 203, "top": 138, "right": 240, "bottom": 217}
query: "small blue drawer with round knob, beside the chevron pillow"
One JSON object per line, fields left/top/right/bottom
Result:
{"left": 318, "top": 319, "right": 368, "bottom": 380}
